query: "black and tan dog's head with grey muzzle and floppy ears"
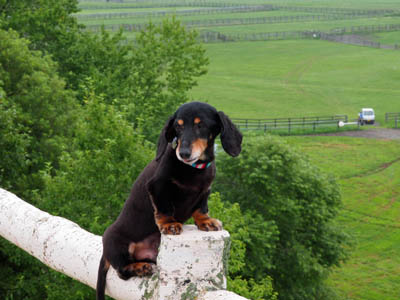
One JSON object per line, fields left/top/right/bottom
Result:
{"left": 156, "top": 102, "right": 242, "bottom": 164}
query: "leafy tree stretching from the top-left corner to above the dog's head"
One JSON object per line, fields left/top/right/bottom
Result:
{"left": 0, "top": 0, "right": 208, "bottom": 142}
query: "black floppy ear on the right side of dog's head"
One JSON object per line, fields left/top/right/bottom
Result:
{"left": 218, "top": 111, "right": 242, "bottom": 157}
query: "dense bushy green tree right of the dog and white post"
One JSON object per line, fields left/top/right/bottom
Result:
{"left": 216, "top": 136, "right": 346, "bottom": 299}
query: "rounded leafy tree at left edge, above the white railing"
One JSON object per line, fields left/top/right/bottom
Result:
{"left": 0, "top": 29, "right": 76, "bottom": 199}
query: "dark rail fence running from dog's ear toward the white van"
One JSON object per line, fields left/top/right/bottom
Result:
{"left": 232, "top": 115, "right": 348, "bottom": 134}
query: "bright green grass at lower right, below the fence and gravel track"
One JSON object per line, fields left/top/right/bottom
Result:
{"left": 286, "top": 137, "right": 400, "bottom": 300}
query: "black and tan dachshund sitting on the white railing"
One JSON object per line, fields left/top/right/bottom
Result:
{"left": 97, "top": 102, "right": 242, "bottom": 300}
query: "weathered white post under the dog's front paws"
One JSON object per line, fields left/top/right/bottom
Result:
{"left": 157, "top": 225, "right": 230, "bottom": 300}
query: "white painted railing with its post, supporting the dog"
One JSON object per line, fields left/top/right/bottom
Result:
{"left": 0, "top": 188, "right": 245, "bottom": 300}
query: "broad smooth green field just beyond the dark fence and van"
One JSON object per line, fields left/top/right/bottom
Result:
{"left": 192, "top": 40, "right": 400, "bottom": 122}
